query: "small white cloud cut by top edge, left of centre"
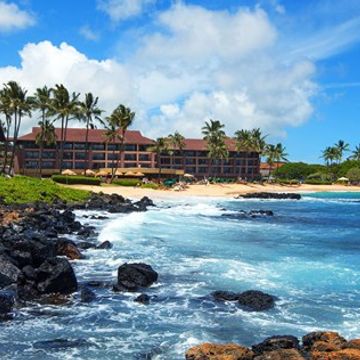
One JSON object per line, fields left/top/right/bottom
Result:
{"left": 98, "top": 0, "right": 155, "bottom": 22}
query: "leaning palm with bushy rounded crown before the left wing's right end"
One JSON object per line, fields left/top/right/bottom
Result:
{"left": 109, "top": 104, "right": 135, "bottom": 182}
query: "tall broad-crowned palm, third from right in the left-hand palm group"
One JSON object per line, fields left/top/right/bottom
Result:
{"left": 51, "top": 84, "right": 80, "bottom": 172}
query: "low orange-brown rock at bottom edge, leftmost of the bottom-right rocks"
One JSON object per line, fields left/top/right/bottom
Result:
{"left": 185, "top": 343, "right": 254, "bottom": 360}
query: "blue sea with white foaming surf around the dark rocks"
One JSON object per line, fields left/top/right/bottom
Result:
{"left": 0, "top": 193, "right": 360, "bottom": 360}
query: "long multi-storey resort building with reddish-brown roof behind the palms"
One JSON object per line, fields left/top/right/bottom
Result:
{"left": 15, "top": 127, "right": 260, "bottom": 179}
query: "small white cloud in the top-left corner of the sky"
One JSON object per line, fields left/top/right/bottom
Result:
{"left": 0, "top": 1, "right": 35, "bottom": 32}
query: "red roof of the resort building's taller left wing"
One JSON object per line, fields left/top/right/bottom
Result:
{"left": 18, "top": 127, "right": 153, "bottom": 145}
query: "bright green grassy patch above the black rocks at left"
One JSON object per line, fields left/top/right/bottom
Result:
{"left": 0, "top": 176, "right": 90, "bottom": 205}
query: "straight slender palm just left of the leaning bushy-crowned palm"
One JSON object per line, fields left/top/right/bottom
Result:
{"left": 79, "top": 93, "right": 103, "bottom": 174}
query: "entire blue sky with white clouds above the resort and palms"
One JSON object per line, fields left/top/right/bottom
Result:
{"left": 0, "top": 0, "right": 360, "bottom": 162}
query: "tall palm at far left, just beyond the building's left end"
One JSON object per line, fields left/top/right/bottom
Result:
{"left": 4, "top": 81, "right": 32, "bottom": 173}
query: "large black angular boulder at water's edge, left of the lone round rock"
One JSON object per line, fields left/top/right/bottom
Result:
{"left": 37, "top": 258, "right": 77, "bottom": 294}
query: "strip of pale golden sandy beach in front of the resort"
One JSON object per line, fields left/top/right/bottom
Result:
{"left": 70, "top": 184, "right": 360, "bottom": 199}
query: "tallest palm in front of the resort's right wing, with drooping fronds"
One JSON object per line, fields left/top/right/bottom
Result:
{"left": 202, "top": 119, "right": 229, "bottom": 175}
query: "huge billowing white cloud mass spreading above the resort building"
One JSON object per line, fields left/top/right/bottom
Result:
{"left": 0, "top": 3, "right": 317, "bottom": 137}
